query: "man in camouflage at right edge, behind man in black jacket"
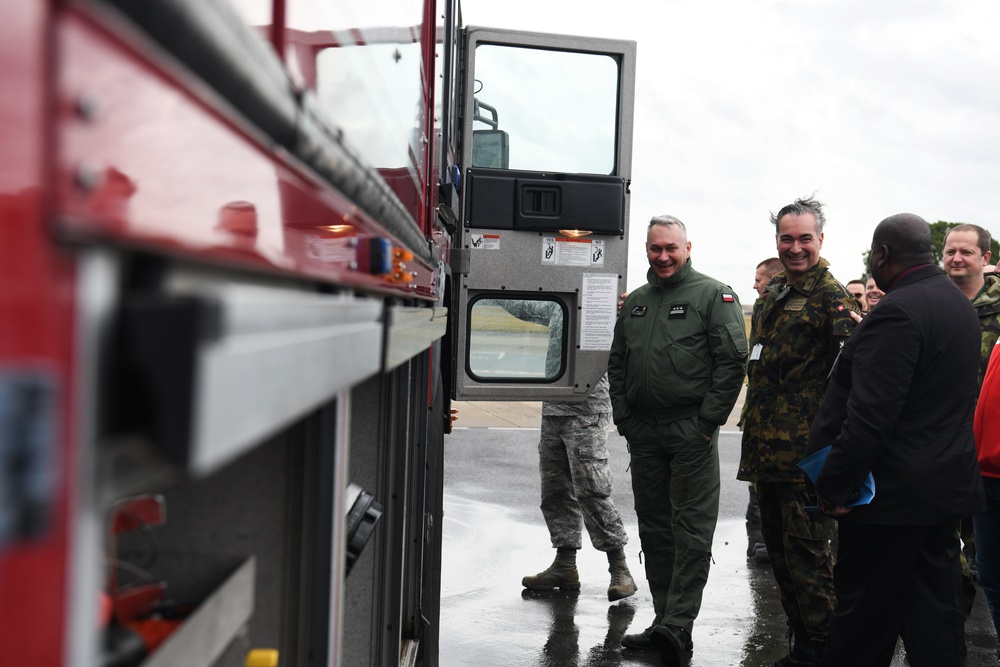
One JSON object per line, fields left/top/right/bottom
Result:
{"left": 942, "top": 225, "right": 1000, "bottom": 604}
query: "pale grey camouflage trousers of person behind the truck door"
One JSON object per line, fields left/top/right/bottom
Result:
{"left": 538, "top": 413, "right": 628, "bottom": 551}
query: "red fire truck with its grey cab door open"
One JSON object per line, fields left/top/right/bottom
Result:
{"left": 0, "top": 0, "right": 635, "bottom": 667}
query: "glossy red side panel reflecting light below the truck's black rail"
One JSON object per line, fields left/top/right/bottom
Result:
{"left": 56, "top": 8, "right": 436, "bottom": 297}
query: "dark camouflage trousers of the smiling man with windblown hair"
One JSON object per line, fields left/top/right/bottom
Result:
{"left": 757, "top": 482, "right": 837, "bottom": 641}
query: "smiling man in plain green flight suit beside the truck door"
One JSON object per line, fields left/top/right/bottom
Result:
{"left": 608, "top": 216, "right": 748, "bottom": 666}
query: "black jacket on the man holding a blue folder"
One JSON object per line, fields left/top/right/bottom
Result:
{"left": 809, "top": 265, "right": 985, "bottom": 525}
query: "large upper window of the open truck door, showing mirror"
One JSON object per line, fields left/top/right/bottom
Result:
{"left": 473, "top": 44, "right": 619, "bottom": 174}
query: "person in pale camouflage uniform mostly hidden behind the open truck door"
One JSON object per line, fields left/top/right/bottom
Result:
{"left": 496, "top": 299, "right": 636, "bottom": 602}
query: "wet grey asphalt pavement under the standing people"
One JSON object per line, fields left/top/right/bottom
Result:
{"left": 440, "top": 428, "right": 997, "bottom": 667}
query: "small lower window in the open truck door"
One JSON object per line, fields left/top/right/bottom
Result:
{"left": 468, "top": 297, "right": 566, "bottom": 382}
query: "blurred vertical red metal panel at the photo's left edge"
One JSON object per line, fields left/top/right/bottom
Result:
{"left": 0, "top": 2, "right": 76, "bottom": 667}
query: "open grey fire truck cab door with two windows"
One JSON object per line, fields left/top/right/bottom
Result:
{"left": 452, "top": 27, "right": 636, "bottom": 402}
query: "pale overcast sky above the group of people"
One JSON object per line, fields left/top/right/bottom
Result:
{"left": 462, "top": 0, "right": 1000, "bottom": 303}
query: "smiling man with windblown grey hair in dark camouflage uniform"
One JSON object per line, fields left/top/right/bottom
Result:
{"left": 738, "top": 199, "right": 859, "bottom": 667}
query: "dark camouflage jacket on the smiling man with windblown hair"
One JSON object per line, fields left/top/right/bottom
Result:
{"left": 737, "top": 259, "right": 858, "bottom": 482}
